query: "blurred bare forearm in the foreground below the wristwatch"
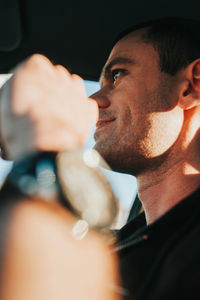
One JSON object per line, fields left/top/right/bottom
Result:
{"left": 1, "top": 199, "right": 122, "bottom": 300}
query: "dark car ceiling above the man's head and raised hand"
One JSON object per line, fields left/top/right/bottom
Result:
{"left": 0, "top": 0, "right": 200, "bottom": 80}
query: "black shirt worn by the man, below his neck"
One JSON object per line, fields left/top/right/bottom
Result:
{"left": 116, "top": 189, "right": 200, "bottom": 300}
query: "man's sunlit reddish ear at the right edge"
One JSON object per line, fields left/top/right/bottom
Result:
{"left": 178, "top": 59, "right": 200, "bottom": 110}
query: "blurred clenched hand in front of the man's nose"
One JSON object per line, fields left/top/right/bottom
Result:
{"left": 3, "top": 54, "right": 98, "bottom": 159}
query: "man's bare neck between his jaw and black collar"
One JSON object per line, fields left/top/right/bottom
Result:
{"left": 137, "top": 161, "right": 200, "bottom": 224}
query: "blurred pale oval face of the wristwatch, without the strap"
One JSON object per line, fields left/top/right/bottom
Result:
{"left": 57, "top": 149, "right": 118, "bottom": 230}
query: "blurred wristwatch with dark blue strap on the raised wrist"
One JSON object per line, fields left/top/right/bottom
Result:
{"left": 7, "top": 149, "right": 119, "bottom": 233}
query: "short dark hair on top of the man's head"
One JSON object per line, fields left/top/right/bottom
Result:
{"left": 115, "top": 18, "right": 200, "bottom": 75}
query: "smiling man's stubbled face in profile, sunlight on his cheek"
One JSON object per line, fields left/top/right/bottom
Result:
{"left": 92, "top": 29, "right": 183, "bottom": 175}
